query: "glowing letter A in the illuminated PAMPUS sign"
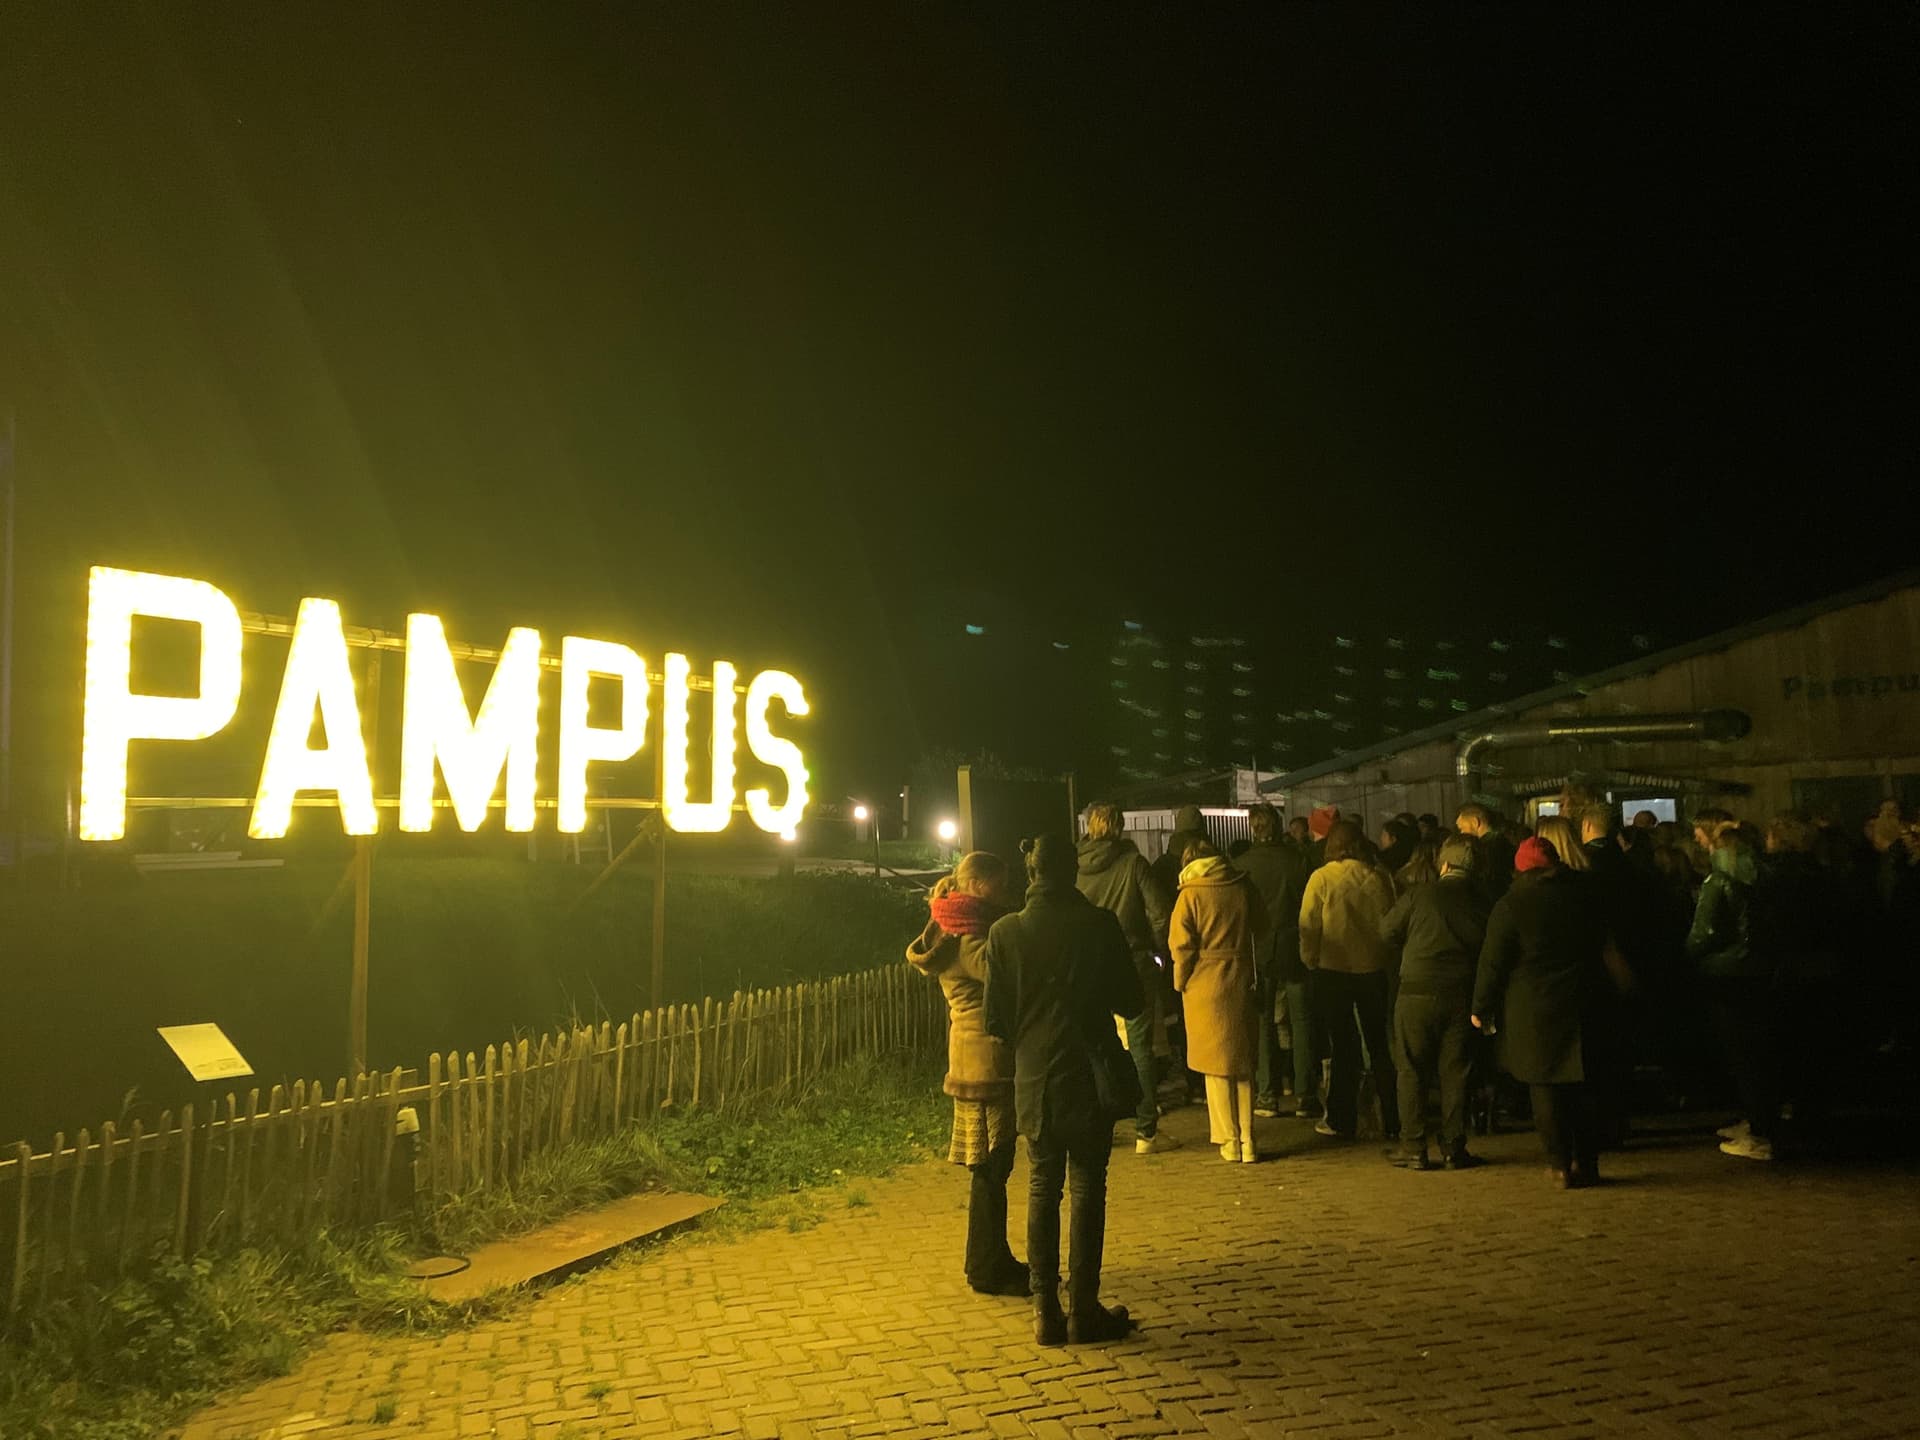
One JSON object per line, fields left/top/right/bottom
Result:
{"left": 246, "top": 597, "right": 380, "bottom": 839}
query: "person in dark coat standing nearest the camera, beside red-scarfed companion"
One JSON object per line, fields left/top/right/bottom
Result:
{"left": 985, "top": 835, "right": 1144, "bottom": 1346}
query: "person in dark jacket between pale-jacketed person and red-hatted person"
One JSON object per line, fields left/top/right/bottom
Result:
{"left": 1382, "top": 835, "right": 1490, "bottom": 1169}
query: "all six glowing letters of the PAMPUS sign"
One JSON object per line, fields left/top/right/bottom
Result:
{"left": 81, "top": 566, "right": 806, "bottom": 841}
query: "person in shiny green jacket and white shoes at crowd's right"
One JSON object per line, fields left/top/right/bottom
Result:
{"left": 1686, "top": 824, "right": 1780, "bottom": 1160}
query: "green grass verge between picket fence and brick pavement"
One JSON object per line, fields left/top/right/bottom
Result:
{"left": 0, "top": 1064, "right": 950, "bottom": 1440}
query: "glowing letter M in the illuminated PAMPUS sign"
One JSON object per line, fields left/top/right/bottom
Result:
{"left": 399, "top": 614, "right": 540, "bottom": 833}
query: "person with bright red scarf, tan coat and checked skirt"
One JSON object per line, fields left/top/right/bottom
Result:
{"left": 906, "top": 851, "right": 1027, "bottom": 1296}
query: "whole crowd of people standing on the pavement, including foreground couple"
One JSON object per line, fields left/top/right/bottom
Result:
{"left": 908, "top": 783, "right": 1920, "bottom": 1344}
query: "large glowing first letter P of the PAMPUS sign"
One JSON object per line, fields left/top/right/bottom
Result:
{"left": 81, "top": 564, "right": 240, "bottom": 841}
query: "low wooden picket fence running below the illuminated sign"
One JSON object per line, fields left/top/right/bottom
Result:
{"left": 0, "top": 966, "right": 947, "bottom": 1323}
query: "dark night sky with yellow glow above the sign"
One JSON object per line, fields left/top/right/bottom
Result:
{"left": 0, "top": 4, "right": 1920, "bottom": 817}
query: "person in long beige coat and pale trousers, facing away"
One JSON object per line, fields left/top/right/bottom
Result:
{"left": 1167, "top": 841, "right": 1273, "bottom": 1165}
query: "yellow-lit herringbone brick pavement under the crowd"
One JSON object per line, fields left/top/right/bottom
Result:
{"left": 180, "top": 1110, "right": 1920, "bottom": 1440}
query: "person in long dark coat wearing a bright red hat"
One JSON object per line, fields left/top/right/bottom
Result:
{"left": 1473, "top": 835, "right": 1607, "bottom": 1188}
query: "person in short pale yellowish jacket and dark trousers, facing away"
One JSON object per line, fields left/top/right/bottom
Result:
{"left": 1300, "top": 820, "right": 1400, "bottom": 1140}
